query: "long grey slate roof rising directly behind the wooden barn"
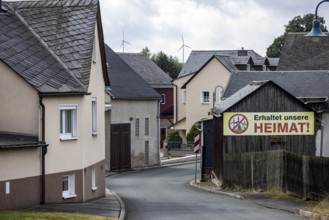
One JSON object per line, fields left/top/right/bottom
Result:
{"left": 223, "top": 71, "right": 329, "bottom": 98}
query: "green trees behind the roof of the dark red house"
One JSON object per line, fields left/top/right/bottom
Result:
{"left": 141, "top": 47, "right": 183, "bottom": 79}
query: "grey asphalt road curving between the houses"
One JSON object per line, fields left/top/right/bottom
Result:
{"left": 106, "top": 164, "right": 303, "bottom": 220}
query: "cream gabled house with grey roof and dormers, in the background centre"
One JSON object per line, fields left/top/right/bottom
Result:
{"left": 173, "top": 49, "right": 273, "bottom": 142}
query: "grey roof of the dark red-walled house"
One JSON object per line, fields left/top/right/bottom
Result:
{"left": 118, "top": 53, "right": 173, "bottom": 88}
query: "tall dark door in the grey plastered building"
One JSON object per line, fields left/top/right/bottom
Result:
{"left": 110, "top": 124, "right": 131, "bottom": 171}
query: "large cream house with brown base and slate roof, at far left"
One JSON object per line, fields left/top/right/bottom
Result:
{"left": 0, "top": 0, "right": 109, "bottom": 209}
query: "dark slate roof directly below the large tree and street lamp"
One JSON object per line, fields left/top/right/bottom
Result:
{"left": 277, "top": 33, "right": 329, "bottom": 71}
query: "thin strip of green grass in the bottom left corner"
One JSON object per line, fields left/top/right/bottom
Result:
{"left": 0, "top": 211, "right": 116, "bottom": 220}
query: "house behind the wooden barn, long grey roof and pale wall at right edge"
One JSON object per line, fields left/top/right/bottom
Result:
{"left": 219, "top": 70, "right": 329, "bottom": 157}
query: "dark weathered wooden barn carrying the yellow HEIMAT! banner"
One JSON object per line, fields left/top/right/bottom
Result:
{"left": 212, "top": 80, "right": 318, "bottom": 186}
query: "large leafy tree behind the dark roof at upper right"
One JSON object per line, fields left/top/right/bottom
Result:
{"left": 266, "top": 13, "right": 328, "bottom": 57}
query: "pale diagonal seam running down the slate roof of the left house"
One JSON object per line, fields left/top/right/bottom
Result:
{"left": 7, "top": 4, "right": 87, "bottom": 90}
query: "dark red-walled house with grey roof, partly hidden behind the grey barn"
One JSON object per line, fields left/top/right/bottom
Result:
{"left": 118, "top": 53, "right": 174, "bottom": 148}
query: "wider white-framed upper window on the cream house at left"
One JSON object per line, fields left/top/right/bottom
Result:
{"left": 60, "top": 105, "right": 77, "bottom": 140}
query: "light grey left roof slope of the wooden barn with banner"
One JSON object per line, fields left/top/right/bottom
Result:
{"left": 212, "top": 80, "right": 269, "bottom": 115}
